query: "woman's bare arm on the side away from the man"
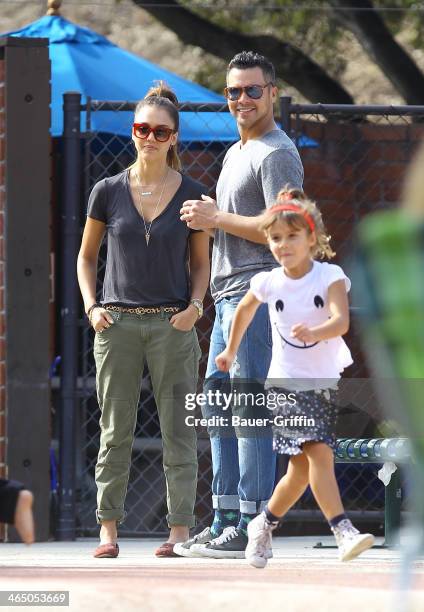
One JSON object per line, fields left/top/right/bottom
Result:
{"left": 77, "top": 217, "right": 113, "bottom": 329}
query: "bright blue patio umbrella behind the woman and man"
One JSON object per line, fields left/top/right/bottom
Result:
{"left": 2, "top": 15, "right": 317, "bottom": 147}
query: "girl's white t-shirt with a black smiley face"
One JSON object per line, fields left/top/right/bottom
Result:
{"left": 250, "top": 261, "right": 353, "bottom": 389}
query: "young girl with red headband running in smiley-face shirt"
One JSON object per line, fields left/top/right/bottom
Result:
{"left": 216, "top": 188, "right": 374, "bottom": 568}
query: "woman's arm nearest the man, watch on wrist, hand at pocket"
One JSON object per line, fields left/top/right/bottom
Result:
{"left": 169, "top": 232, "right": 210, "bottom": 331}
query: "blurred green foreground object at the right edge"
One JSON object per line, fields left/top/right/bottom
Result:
{"left": 353, "top": 142, "right": 424, "bottom": 610}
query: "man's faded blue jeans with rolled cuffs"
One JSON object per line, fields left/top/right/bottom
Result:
{"left": 202, "top": 296, "right": 276, "bottom": 514}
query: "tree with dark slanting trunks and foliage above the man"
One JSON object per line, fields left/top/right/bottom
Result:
{"left": 133, "top": 0, "right": 424, "bottom": 104}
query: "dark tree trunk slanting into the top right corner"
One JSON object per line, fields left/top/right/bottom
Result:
{"left": 329, "top": 0, "right": 424, "bottom": 104}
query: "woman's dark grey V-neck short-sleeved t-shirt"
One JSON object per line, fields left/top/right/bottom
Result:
{"left": 87, "top": 170, "right": 206, "bottom": 306}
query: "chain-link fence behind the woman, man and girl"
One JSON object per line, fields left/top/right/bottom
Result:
{"left": 68, "top": 98, "right": 424, "bottom": 535}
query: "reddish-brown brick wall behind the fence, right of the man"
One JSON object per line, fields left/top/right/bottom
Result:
{"left": 299, "top": 118, "right": 424, "bottom": 378}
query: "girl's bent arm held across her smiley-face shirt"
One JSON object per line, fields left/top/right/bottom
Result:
{"left": 291, "top": 280, "right": 349, "bottom": 342}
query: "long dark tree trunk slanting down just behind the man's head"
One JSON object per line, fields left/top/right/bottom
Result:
{"left": 133, "top": 0, "right": 354, "bottom": 104}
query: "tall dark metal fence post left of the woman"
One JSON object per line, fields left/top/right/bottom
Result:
{"left": 57, "top": 92, "right": 81, "bottom": 541}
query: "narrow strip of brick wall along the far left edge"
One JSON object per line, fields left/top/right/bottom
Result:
{"left": 0, "top": 53, "right": 7, "bottom": 540}
